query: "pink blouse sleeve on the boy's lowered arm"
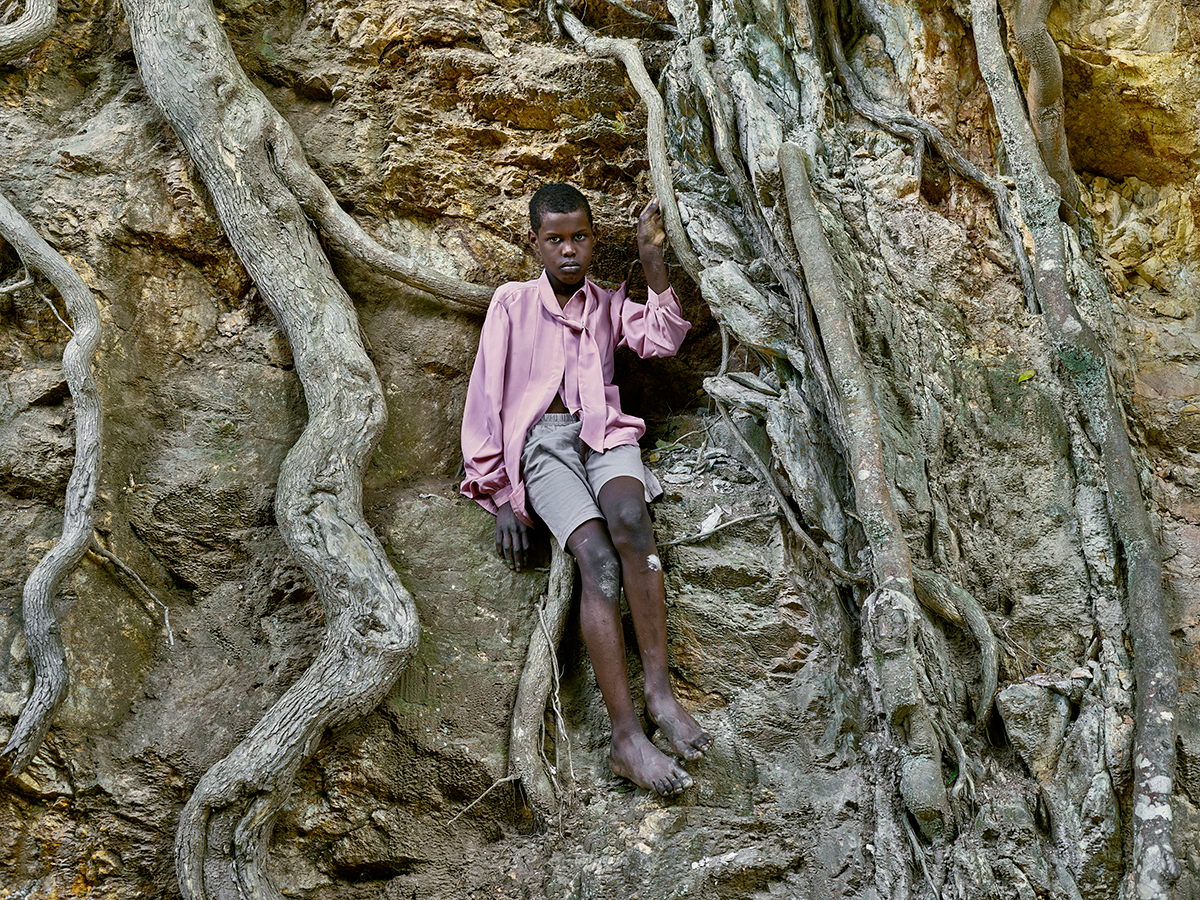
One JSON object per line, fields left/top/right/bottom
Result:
{"left": 460, "top": 300, "right": 512, "bottom": 512}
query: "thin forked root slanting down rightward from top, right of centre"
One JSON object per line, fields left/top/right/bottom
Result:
{"left": 822, "top": 0, "right": 1041, "bottom": 312}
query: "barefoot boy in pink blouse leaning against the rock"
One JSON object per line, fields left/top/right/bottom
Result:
{"left": 462, "top": 185, "right": 713, "bottom": 794}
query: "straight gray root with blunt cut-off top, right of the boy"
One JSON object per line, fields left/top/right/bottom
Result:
{"left": 779, "top": 143, "right": 949, "bottom": 836}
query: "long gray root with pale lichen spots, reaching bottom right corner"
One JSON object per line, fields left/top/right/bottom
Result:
{"left": 971, "top": 0, "right": 1178, "bottom": 898}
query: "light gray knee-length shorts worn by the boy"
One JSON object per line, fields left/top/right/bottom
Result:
{"left": 521, "top": 413, "right": 661, "bottom": 550}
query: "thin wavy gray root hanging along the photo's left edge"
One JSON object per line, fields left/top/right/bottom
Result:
{"left": 0, "top": 190, "right": 103, "bottom": 775}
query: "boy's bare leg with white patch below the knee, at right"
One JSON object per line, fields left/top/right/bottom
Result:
{"left": 598, "top": 478, "right": 713, "bottom": 760}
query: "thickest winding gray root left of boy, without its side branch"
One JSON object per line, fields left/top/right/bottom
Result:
{"left": 124, "top": 0, "right": 419, "bottom": 900}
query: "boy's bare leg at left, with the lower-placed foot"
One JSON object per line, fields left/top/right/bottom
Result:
{"left": 566, "top": 518, "right": 691, "bottom": 794}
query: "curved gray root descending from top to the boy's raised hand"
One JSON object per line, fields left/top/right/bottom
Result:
{"left": 552, "top": 0, "right": 704, "bottom": 284}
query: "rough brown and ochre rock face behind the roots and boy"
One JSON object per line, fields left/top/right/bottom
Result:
{"left": 0, "top": 0, "right": 1200, "bottom": 900}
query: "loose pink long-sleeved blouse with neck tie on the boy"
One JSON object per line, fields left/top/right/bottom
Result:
{"left": 462, "top": 272, "right": 691, "bottom": 523}
